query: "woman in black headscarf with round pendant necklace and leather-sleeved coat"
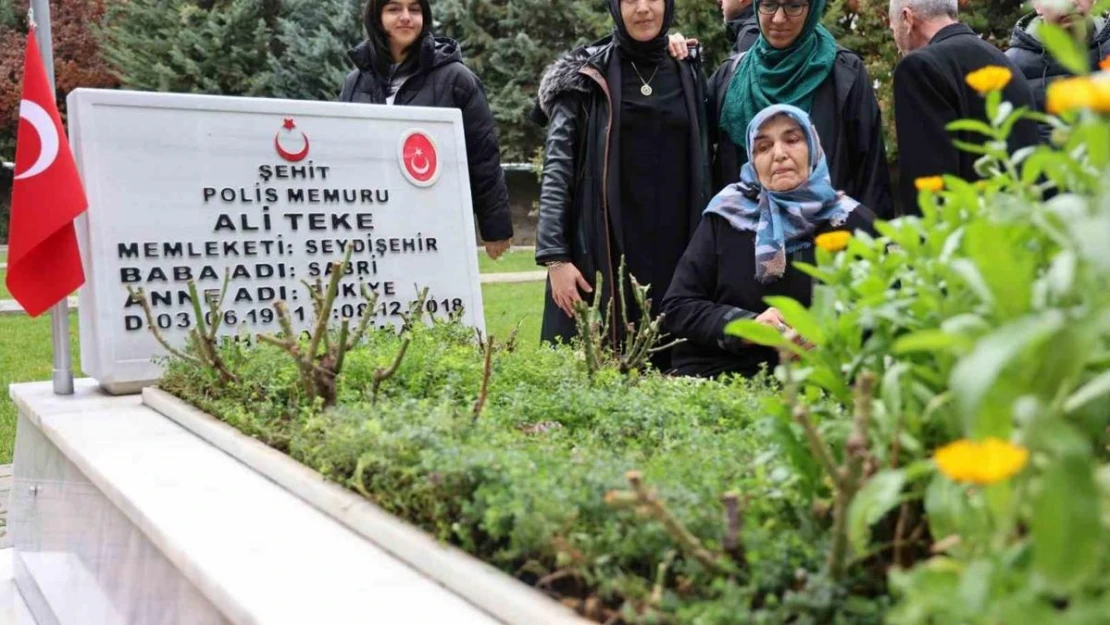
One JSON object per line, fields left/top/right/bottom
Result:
{"left": 535, "top": 0, "right": 709, "bottom": 369}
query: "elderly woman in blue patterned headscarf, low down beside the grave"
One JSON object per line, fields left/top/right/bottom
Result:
{"left": 663, "top": 104, "right": 875, "bottom": 376}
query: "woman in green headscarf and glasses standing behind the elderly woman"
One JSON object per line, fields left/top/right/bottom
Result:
{"left": 709, "top": 0, "right": 895, "bottom": 219}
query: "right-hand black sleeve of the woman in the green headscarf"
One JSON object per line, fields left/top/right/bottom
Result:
{"left": 845, "top": 63, "right": 895, "bottom": 219}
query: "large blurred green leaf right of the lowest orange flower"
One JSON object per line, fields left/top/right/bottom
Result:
{"left": 1030, "top": 454, "right": 1102, "bottom": 594}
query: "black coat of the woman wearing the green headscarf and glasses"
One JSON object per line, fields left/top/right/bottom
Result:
{"left": 707, "top": 47, "right": 895, "bottom": 219}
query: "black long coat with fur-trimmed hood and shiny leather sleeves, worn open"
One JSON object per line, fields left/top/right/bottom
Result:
{"left": 533, "top": 38, "right": 709, "bottom": 342}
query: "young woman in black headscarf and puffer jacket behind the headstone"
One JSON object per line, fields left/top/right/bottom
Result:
{"left": 340, "top": 0, "right": 513, "bottom": 259}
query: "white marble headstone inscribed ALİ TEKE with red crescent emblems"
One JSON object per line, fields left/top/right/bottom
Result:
{"left": 68, "top": 89, "right": 484, "bottom": 392}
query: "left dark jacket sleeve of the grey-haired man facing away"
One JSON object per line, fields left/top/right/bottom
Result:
{"left": 894, "top": 54, "right": 959, "bottom": 214}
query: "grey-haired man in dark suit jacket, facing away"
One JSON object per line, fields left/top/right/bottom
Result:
{"left": 890, "top": 0, "right": 1038, "bottom": 214}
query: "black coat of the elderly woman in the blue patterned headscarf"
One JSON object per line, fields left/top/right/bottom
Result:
{"left": 663, "top": 205, "right": 875, "bottom": 377}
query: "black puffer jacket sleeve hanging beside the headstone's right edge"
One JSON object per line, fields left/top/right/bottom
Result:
{"left": 460, "top": 72, "right": 513, "bottom": 241}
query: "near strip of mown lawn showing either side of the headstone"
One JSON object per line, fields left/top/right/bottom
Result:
{"left": 0, "top": 282, "right": 544, "bottom": 464}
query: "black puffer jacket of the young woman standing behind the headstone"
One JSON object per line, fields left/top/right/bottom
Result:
{"left": 340, "top": 37, "right": 513, "bottom": 241}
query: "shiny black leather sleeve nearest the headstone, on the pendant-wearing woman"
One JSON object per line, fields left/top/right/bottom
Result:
{"left": 536, "top": 95, "right": 581, "bottom": 264}
